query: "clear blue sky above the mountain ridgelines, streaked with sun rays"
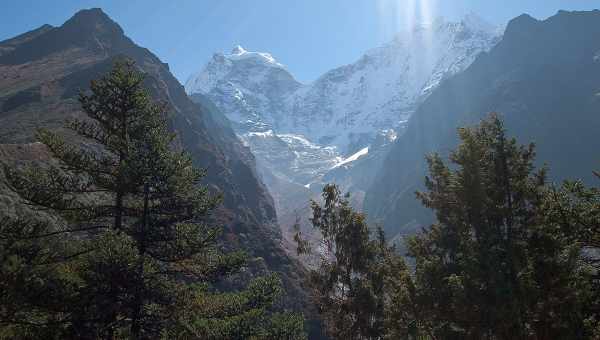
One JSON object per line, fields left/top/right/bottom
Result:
{"left": 0, "top": 0, "right": 600, "bottom": 82}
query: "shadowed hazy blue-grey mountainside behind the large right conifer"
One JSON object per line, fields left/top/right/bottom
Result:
{"left": 365, "top": 11, "right": 600, "bottom": 236}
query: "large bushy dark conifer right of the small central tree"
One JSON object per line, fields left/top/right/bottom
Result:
{"left": 395, "top": 115, "right": 591, "bottom": 339}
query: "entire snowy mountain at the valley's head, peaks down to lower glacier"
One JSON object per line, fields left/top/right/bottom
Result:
{"left": 186, "top": 14, "right": 501, "bottom": 247}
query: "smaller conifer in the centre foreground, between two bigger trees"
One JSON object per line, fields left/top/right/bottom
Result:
{"left": 295, "top": 185, "right": 407, "bottom": 339}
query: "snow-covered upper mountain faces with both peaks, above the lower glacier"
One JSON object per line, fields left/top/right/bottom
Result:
{"left": 186, "top": 14, "right": 500, "bottom": 155}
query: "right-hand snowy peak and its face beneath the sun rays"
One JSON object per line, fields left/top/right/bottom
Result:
{"left": 279, "top": 15, "right": 498, "bottom": 154}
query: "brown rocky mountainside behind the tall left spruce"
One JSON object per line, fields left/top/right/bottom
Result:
{"left": 0, "top": 9, "right": 310, "bottom": 314}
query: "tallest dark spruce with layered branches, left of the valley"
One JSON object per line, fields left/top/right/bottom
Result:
{"left": 2, "top": 61, "right": 304, "bottom": 339}
